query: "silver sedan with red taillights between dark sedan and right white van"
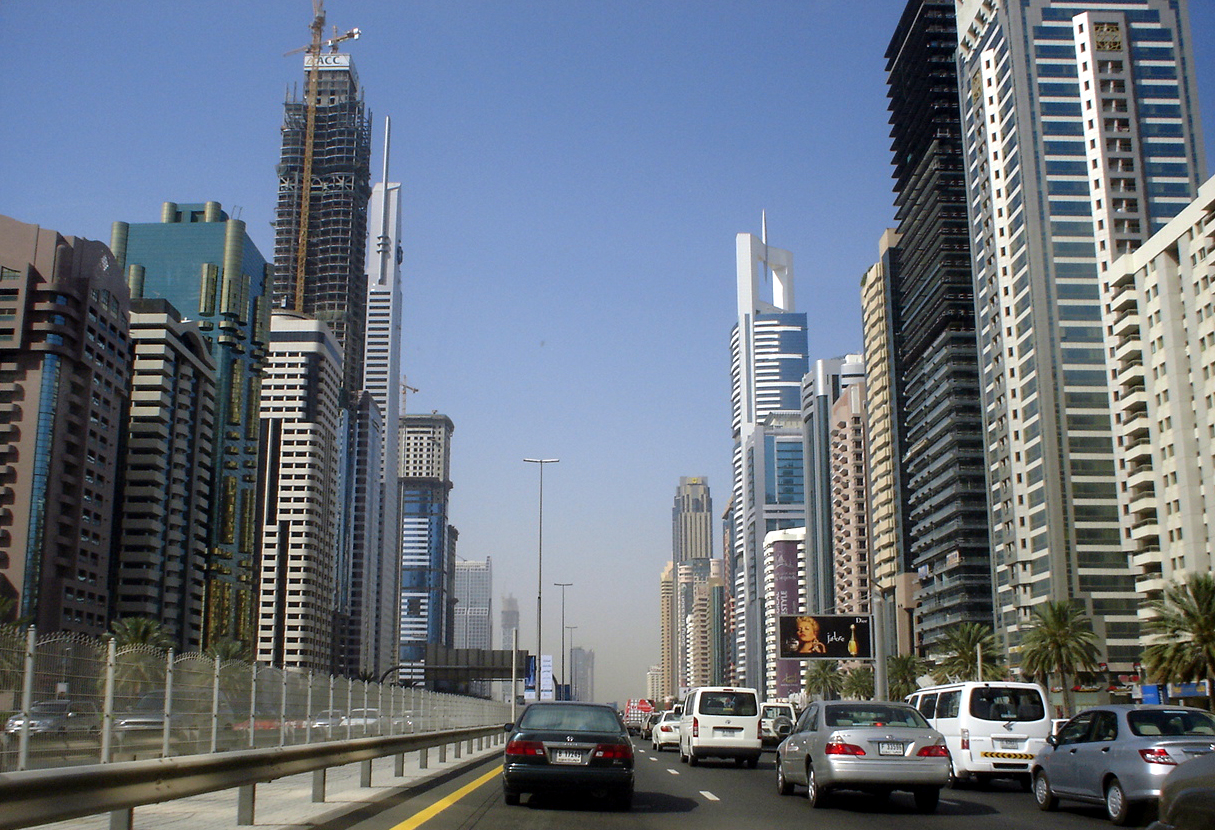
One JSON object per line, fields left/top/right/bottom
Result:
{"left": 776, "top": 700, "right": 949, "bottom": 813}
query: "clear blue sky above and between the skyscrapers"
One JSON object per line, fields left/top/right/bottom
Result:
{"left": 7, "top": 0, "right": 1215, "bottom": 702}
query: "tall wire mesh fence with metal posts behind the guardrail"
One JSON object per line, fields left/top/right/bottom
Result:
{"left": 0, "top": 629, "right": 510, "bottom": 770}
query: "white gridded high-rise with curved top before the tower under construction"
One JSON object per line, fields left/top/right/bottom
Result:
{"left": 256, "top": 311, "right": 344, "bottom": 672}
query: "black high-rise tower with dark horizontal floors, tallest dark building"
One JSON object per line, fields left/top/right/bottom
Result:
{"left": 875, "top": 0, "right": 994, "bottom": 654}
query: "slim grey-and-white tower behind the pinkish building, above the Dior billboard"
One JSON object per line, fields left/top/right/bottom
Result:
{"left": 799, "top": 355, "right": 865, "bottom": 614}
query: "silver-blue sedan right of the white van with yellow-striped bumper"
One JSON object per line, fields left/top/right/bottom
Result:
{"left": 1032, "top": 704, "right": 1215, "bottom": 824}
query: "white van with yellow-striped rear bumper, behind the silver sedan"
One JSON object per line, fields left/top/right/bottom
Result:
{"left": 906, "top": 681, "right": 1051, "bottom": 791}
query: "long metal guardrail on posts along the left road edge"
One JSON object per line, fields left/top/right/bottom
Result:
{"left": 0, "top": 724, "right": 505, "bottom": 830}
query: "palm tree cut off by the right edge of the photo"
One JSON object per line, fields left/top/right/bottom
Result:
{"left": 1143, "top": 574, "right": 1215, "bottom": 712}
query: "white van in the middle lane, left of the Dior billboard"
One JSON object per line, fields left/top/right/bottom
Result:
{"left": 679, "top": 685, "right": 763, "bottom": 769}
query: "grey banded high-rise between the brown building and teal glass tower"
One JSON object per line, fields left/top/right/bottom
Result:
{"left": 113, "top": 299, "right": 215, "bottom": 653}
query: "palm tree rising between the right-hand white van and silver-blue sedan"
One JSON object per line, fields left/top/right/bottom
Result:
{"left": 1021, "top": 599, "right": 1098, "bottom": 716}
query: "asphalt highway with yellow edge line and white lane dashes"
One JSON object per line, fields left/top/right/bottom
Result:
{"left": 345, "top": 741, "right": 1127, "bottom": 830}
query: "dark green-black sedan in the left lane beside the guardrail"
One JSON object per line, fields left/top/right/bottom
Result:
{"left": 502, "top": 701, "right": 633, "bottom": 809}
